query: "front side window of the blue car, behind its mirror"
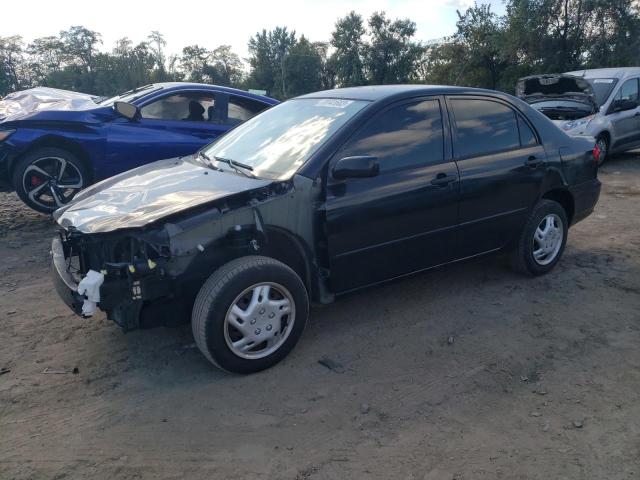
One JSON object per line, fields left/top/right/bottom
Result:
{"left": 141, "top": 92, "right": 215, "bottom": 122}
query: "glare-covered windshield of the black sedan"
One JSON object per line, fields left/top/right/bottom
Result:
{"left": 203, "top": 98, "right": 369, "bottom": 180}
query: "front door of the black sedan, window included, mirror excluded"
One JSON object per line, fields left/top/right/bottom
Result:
{"left": 326, "top": 97, "right": 458, "bottom": 292}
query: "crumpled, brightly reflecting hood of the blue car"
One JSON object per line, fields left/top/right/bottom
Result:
{"left": 0, "top": 87, "right": 98, "bottom": 122}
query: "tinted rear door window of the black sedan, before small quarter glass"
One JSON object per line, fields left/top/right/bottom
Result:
{"left": 451, "top": 98, "right": 520, "bottom": 158}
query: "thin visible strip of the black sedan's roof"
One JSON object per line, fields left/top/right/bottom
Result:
{"left": 297, "top": 84, "right": 500, "bottom": 102}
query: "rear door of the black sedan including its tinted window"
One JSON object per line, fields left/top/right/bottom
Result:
{"left": 447, "top": 95, "right": 546, "bottom": 258}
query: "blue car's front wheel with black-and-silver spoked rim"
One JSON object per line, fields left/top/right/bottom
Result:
{"left": 11, "top": 147, "right": 90, "bottom": 213}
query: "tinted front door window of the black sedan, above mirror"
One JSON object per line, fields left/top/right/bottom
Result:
{"left": 340, "top": 100, "right": 444, "bottom": 172}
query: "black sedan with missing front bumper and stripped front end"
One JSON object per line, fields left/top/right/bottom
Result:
{"left": 52, "top": 85, "right": 600, "bottom": 373}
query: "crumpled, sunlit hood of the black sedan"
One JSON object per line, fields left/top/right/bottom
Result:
{"left": 53, "top": 156, "right": 272, "bottom": 233}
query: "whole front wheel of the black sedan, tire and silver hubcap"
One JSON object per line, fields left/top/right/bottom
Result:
{"left": 191, "top": 256, "right": 309, "bottom": 374}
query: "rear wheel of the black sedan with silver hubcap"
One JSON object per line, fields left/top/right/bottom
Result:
{"left": 511, "top": 200, "right": 569, "bottom": 275}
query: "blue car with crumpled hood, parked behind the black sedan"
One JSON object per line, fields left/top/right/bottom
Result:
{"left": 0, "top": 83, "right": 278, "bottom": 213}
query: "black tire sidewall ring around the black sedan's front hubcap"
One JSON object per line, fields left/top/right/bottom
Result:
{"left": 205, "top": 264, "right": 309, "bottom": 373}
